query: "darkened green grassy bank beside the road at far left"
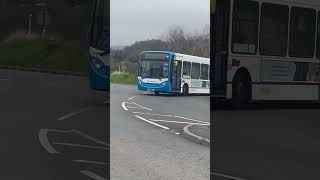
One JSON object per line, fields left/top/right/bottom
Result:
{"left": 0, "top": 39, "right": 87, "bottom": 72}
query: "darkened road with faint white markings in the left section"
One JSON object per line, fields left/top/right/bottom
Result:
{"left": 0, "top": 70, "right": 110, "bottom": 180}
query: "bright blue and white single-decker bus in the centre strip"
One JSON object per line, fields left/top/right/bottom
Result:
{"left": 137, "top": 51, "right": 210, "bottom": 95}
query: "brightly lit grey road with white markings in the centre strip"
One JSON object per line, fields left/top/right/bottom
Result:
{"left": 110, "top": 84, "right": 210, "bottom": 180}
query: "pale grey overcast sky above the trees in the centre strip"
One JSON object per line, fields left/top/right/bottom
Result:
{"left": 110, "top": 0, "right": 210, "bottom": 46}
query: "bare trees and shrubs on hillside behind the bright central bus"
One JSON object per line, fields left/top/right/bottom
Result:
{"left": 110, "top": 26, "right": 210, "bottom": 74}
